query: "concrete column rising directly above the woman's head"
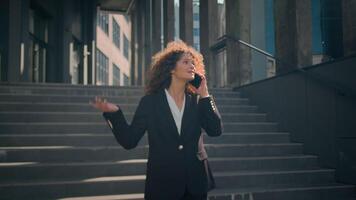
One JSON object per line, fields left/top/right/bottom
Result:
{"left": 179, "top": 0, "right": 193, "bottom": 45}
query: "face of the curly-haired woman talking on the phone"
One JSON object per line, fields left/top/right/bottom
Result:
{"left": 172, "top": 53, "right": 195, "bottom": 82}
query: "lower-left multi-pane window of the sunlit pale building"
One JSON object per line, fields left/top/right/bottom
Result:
{"left": 96, "top": 49, "right": 109, "bottom": 85}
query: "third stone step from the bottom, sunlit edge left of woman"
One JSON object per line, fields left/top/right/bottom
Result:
{"left": 0, "top": 155, "right": 318, "bottom": 183}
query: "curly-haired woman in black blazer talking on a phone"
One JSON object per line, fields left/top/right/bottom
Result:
{"left": 92, "top": 41, "right": 222, "bottom": 200}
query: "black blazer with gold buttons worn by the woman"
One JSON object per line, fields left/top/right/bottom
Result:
{"left": 103, "top": 90, "right": 222, "bottom": 200}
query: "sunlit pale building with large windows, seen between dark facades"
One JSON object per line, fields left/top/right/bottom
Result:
{"left": 96, "top": 11, "right": 131, "bottom": 86}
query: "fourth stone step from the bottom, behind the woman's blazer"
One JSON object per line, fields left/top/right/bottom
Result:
{"left": 0, "top": 143, "right": 303, "bottom": 162}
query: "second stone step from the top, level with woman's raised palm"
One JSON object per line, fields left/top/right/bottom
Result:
{"left": 0, "top": 94, "right": 249, "bottom": 106}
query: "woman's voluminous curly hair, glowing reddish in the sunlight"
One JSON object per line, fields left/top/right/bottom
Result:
{"left": 145, "top": 41, "right": 205, "bottom": 94}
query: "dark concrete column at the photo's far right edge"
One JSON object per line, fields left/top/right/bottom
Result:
{"left": 341, "top": 0, "right": 356, "bottom": 56}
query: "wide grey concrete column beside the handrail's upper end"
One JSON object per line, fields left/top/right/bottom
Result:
{"left": 225, "top": 0, "right": 252, "bottom": 87}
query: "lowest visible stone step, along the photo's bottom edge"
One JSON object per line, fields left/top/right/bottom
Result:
{"left": 41, "top": 183, "right": 356, "bottom": 200}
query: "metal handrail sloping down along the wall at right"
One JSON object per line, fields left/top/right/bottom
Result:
{"left": 210, "top": 35, "right": 356, "bottom": 98}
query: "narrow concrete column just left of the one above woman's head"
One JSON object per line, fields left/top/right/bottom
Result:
{"left": 163, "top": 0, "right": 174, "bottom": 46}
